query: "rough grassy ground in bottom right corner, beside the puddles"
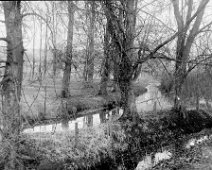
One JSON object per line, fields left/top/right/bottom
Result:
{"left": 152, "top": 130, "right": 212, "bottom": 170}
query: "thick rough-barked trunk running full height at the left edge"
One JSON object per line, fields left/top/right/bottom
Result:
{"left": 2, "top": 1, "right": 24, "bottom": 170}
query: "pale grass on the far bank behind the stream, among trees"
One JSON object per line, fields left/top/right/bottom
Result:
{"left": 21, "top": 69, "right": 148, "bottom": 124}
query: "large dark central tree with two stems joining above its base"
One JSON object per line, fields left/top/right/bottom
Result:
{"left": 105, "top": 0, "right": 137, "bottom": 118}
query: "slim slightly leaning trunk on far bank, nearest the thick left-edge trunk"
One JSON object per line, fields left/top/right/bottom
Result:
{"left": 61, "top": 1, "right": 74, "bottom": 98}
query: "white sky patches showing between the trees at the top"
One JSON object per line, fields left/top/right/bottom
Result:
{"left": 0, "top": 0, "right": 212, "bottom": 55}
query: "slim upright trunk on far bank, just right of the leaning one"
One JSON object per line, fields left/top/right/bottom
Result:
{"left": 85, "top": 1, "right": 95, "bottom": 84}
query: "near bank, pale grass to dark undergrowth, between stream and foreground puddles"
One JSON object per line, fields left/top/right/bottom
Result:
{"left": 15, "top": 110, "right": 212, "bottom": 170}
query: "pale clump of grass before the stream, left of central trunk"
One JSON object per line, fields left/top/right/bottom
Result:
{"left": 25, "top": 124, "right": 124, "bottom": 169}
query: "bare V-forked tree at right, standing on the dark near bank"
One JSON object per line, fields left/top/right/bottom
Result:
{"left": 172, "top": 0, "right": 209, "bottom": 111}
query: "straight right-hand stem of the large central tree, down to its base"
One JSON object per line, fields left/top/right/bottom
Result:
{"left": 119, "top": 0, "right": 138, "bottom": 120}
